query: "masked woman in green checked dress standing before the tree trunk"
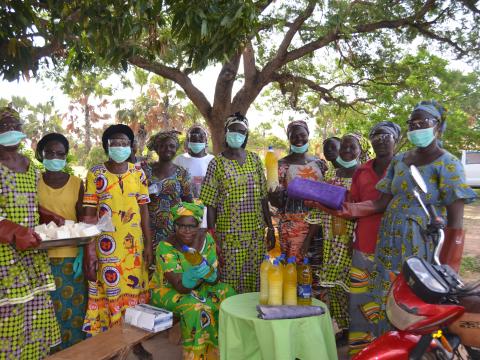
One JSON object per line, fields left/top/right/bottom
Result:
{"left": 200, "top": 113, "right": 275, "bottom": 293}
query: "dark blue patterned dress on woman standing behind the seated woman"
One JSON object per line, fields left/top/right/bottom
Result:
{"left": 143, "top": 164, "right": 192, "bottom": 250}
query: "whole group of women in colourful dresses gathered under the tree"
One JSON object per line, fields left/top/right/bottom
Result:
{"left": 0, "top": 102, "right": 475, "bottom": 359}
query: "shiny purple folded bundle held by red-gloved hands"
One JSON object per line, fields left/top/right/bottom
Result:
{"left": 287, "top": 178, "right": 347, "bottom": 210}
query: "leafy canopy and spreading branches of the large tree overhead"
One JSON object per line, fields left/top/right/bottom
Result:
{"left": 0, "top": 0, "right": 480, "bottom": 150}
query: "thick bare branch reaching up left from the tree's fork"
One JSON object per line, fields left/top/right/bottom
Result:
{"left": 128, "top": 55, "right": 212, "bottom": 119}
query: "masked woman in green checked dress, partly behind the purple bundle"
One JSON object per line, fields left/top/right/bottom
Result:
{"left": 304, "top": 134, "right": 365, "bottom": 340}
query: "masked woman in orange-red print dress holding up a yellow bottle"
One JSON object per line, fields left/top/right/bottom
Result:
{"left": 269, "top": 120, "right": 327, "bottom": 262}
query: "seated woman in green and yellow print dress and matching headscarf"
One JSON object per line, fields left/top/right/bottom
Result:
{"left": 150, "top": 202, "right": 235, "bottom": 359}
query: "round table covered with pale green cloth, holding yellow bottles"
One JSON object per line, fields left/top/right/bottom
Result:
{"left": 219, "top": 293, "right": 337, "bottom": 360}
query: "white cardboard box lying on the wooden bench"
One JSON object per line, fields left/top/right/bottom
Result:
{"left": 125, "top": 304, "right": 173, "bottom": 333}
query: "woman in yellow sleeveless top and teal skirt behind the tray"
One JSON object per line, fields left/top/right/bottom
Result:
{"left": 35, "top": 133, "right": 87, "bottom": 349}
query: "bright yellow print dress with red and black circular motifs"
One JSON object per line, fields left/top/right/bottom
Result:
{"left": 83, "top": 163, "right": 150, "bottom": 335}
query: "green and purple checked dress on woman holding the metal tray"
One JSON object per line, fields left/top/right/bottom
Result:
{"left": 0, "top": 164, "right": 60, "bottom": 360}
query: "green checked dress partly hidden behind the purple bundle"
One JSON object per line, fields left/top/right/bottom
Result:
{"left": 305, "top": 169, "right": 355, "bottom": 330}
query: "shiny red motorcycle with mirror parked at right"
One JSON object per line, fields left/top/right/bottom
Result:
{"left": 353, "top": 165, "right": 480, "bottom": 360}
